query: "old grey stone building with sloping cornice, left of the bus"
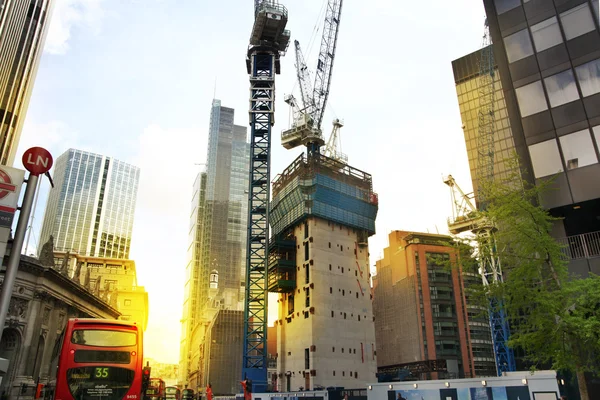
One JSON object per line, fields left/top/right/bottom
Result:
{"left": 0, "top": 242, "right": 121, "bottom": 400}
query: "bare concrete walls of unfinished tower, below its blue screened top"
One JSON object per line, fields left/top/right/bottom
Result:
{"left": 277, "top": 218, "right": 376, "bottom": 391}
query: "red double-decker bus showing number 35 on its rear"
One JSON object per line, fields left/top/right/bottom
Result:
{"left": 54, "top": 318, "right": 143, "bottom": 400}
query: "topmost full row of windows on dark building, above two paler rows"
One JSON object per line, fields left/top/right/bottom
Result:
{"left": 504, "top": 2, "right": 598, "bottom": 63}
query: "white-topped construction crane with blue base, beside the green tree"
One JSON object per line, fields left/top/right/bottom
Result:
{"left": 444, "top": 19, "right": 516, "bottom": 376}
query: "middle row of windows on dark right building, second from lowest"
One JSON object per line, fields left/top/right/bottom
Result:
{"left": 515, "top": 59, "right": 600, "bottom": 117}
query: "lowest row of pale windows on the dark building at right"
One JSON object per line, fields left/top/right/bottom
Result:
{"left": 529, "top": 125, "right": 600, "bottom": 178}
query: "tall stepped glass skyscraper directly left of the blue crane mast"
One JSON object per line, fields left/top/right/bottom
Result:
{"left": 179, "top": 100, "right": 250, "bottom": 393}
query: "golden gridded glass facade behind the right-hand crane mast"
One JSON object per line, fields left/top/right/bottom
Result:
{"left": 452, "top": 47, "right": 515, "bottom": 202}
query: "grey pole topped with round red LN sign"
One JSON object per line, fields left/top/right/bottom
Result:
{"left": 0, "top": 147, "right": 53, "bottom": 338}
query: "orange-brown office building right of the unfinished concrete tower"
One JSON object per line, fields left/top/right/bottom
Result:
{"left": 373, "top": 231, "right": 496, "bottom": 379}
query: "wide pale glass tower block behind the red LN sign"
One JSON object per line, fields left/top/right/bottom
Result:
{"left": 40, "top": 149, "right": 140, "bottom": 259}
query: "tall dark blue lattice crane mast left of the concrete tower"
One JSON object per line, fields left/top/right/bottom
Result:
{"left": 242, "top": 0, "right": 290, "bottom": 392}
